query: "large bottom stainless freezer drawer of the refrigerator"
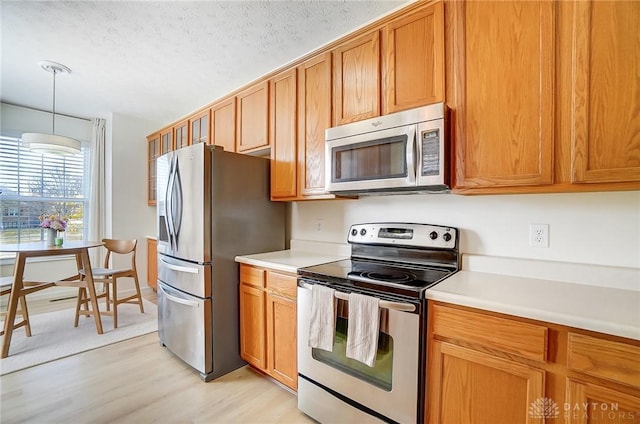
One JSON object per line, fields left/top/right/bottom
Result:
{"left": 158, "top": 281, "right": 213, "bottom": 380}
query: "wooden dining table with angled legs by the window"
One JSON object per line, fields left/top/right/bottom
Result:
{"left": 0, "top": 240, "right": 102, "bottom": 358}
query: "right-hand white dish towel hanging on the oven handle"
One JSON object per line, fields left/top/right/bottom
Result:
{"left": 346, "top": 293, "right": 380, "bottom": 367}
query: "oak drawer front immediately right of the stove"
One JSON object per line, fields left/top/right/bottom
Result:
{"left": 429, "top": 304, "right": 547, "bottom": 361}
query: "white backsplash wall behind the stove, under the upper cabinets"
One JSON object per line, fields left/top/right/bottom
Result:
{"left": 291, "top": 191, "right": 640, "bottom": 268}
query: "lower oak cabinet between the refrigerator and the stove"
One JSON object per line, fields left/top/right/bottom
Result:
{"left": 240, "top": 264, "right": 298, "bottom": 390}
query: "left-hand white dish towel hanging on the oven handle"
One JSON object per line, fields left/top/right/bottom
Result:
{"left": 309, "top": 284, "right": 336, "bottom": 352}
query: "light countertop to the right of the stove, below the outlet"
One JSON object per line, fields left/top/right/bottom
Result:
{"left": 426, "top": 255, "right": 640, "bottom": 340}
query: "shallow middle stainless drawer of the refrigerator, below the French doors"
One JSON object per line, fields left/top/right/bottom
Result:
{"left": 158, "top": 255, "right": 212, "bottom": 298}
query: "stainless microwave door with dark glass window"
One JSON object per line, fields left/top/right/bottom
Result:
{"left": 325, "top": 125, "right": 417, "bottom": 192}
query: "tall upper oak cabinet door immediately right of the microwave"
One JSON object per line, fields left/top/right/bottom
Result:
{"left": 445, "top": 1, "right": 556, "bottom": 188}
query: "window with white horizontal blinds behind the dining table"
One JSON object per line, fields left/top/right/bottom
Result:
{"left": 0, "top": 135, "right": 89, "bottom": 247}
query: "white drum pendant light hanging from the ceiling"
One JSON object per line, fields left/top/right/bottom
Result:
{"left": 22, "top": 61, "right": 81, "bottom": 155}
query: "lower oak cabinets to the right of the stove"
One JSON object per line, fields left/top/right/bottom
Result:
{"left": 425, "top": 302, "right": 640, "bottom": 424}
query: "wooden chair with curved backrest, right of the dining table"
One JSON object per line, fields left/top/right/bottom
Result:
{"left": 74, "top": 239, "right": 144, "bottom": 328}
